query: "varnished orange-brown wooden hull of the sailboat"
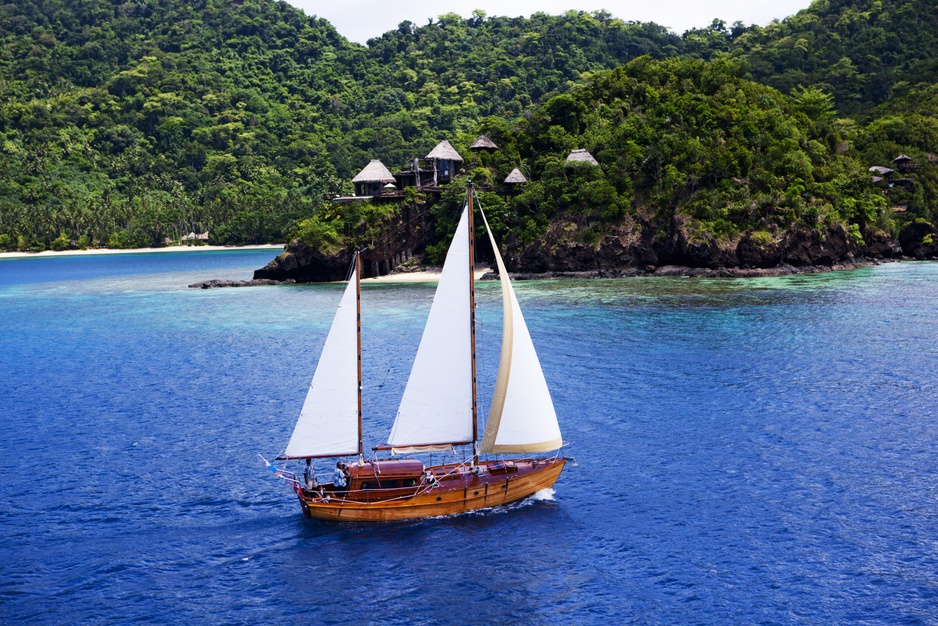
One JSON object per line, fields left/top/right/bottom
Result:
{"left": 297, "top": 458, "right": 566, "bottom": 522}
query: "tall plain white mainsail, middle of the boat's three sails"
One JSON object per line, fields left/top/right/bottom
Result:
{"left": 388, "top": 202, "right": 472, "bottom": 453}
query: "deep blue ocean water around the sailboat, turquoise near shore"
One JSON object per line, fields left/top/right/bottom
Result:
{"left": 0, "top": 250, "right": 938, "bottom": 624}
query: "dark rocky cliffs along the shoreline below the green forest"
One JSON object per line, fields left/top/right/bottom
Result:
{"left": 254, "top": 217, "right": 938, "bottom": 283}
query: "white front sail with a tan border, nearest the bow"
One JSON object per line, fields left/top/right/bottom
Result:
{"left": 481, "top": 213, "right": 563, "bottom": 454}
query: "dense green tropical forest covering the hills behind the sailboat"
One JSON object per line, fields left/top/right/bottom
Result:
{"left": 0, "top": 0, "right": 938, "bottom": 261}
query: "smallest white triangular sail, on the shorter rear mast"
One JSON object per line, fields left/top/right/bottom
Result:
{"left": 283, "top": 264, "right": 359, "bottom": 458}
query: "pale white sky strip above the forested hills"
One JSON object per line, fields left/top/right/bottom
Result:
{"left": 287, "top": 0, "right": 811, "bottom": 43}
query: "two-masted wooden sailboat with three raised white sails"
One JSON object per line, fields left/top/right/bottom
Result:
{"left": 277, "top": 183, "right": 567, "bottom": 522}
